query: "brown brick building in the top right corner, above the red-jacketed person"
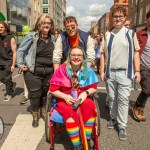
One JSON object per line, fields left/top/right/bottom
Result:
{"left": 128, "top": 0, "right": 150, "bottom": 31}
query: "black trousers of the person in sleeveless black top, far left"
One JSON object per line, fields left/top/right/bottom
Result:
{"left": 0, "top": 65, "right": 13, "bottom": 95}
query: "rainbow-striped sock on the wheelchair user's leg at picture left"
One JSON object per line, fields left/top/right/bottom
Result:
{"left": 66, "top": 122, "right": 81, "bottom": 147}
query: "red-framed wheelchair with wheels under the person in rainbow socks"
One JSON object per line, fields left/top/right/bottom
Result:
{"left": 45, "top": 94, "right": 100, "bottom": 150}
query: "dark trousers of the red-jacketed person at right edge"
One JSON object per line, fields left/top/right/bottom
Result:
{"left": 136, "top": 65, "right": 150, "bottom": 108}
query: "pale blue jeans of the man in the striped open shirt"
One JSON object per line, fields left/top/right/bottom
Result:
{"left": 106, "top": 70, "right": 132, "bottom": 128}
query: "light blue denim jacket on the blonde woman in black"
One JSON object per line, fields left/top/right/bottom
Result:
{"left": 17, "top": 32, "right": 55, "bottom": 73}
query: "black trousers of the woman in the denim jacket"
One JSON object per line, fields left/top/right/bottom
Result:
{"left": 24, "top": 67, "right": 53, "bottom": 112}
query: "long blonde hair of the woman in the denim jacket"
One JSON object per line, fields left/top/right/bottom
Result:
{"left": 33, "top": 14, "right": 54, "bottom": 34}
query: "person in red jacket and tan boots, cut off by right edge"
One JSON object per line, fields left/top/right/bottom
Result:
{"left": 133, "top": 11, "right": 150, "bottom": 121}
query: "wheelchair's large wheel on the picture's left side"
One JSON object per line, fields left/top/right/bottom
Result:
{"left": 45, "top": 94, "right": 51, "bottom": 142}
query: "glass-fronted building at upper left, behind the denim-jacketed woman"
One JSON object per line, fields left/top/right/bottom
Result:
{"left": 6, "top": 0, "right": 29, "bottom": 43}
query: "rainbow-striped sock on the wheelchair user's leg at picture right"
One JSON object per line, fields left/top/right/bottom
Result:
{"left": 84, "top": 117, "right": 95, "bottom": 140}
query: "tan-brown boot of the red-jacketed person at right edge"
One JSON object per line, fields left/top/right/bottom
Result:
{"left": 132, "top": 106, "right": 146, "bottom": 122}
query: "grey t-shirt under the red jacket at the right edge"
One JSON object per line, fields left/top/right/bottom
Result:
{"left": 141, "top": 32, "right": 150, "bottom": 69}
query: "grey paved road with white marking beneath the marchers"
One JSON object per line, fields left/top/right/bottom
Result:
{"left": 0, "top": 69, "right": 150, "bottom": 150}
